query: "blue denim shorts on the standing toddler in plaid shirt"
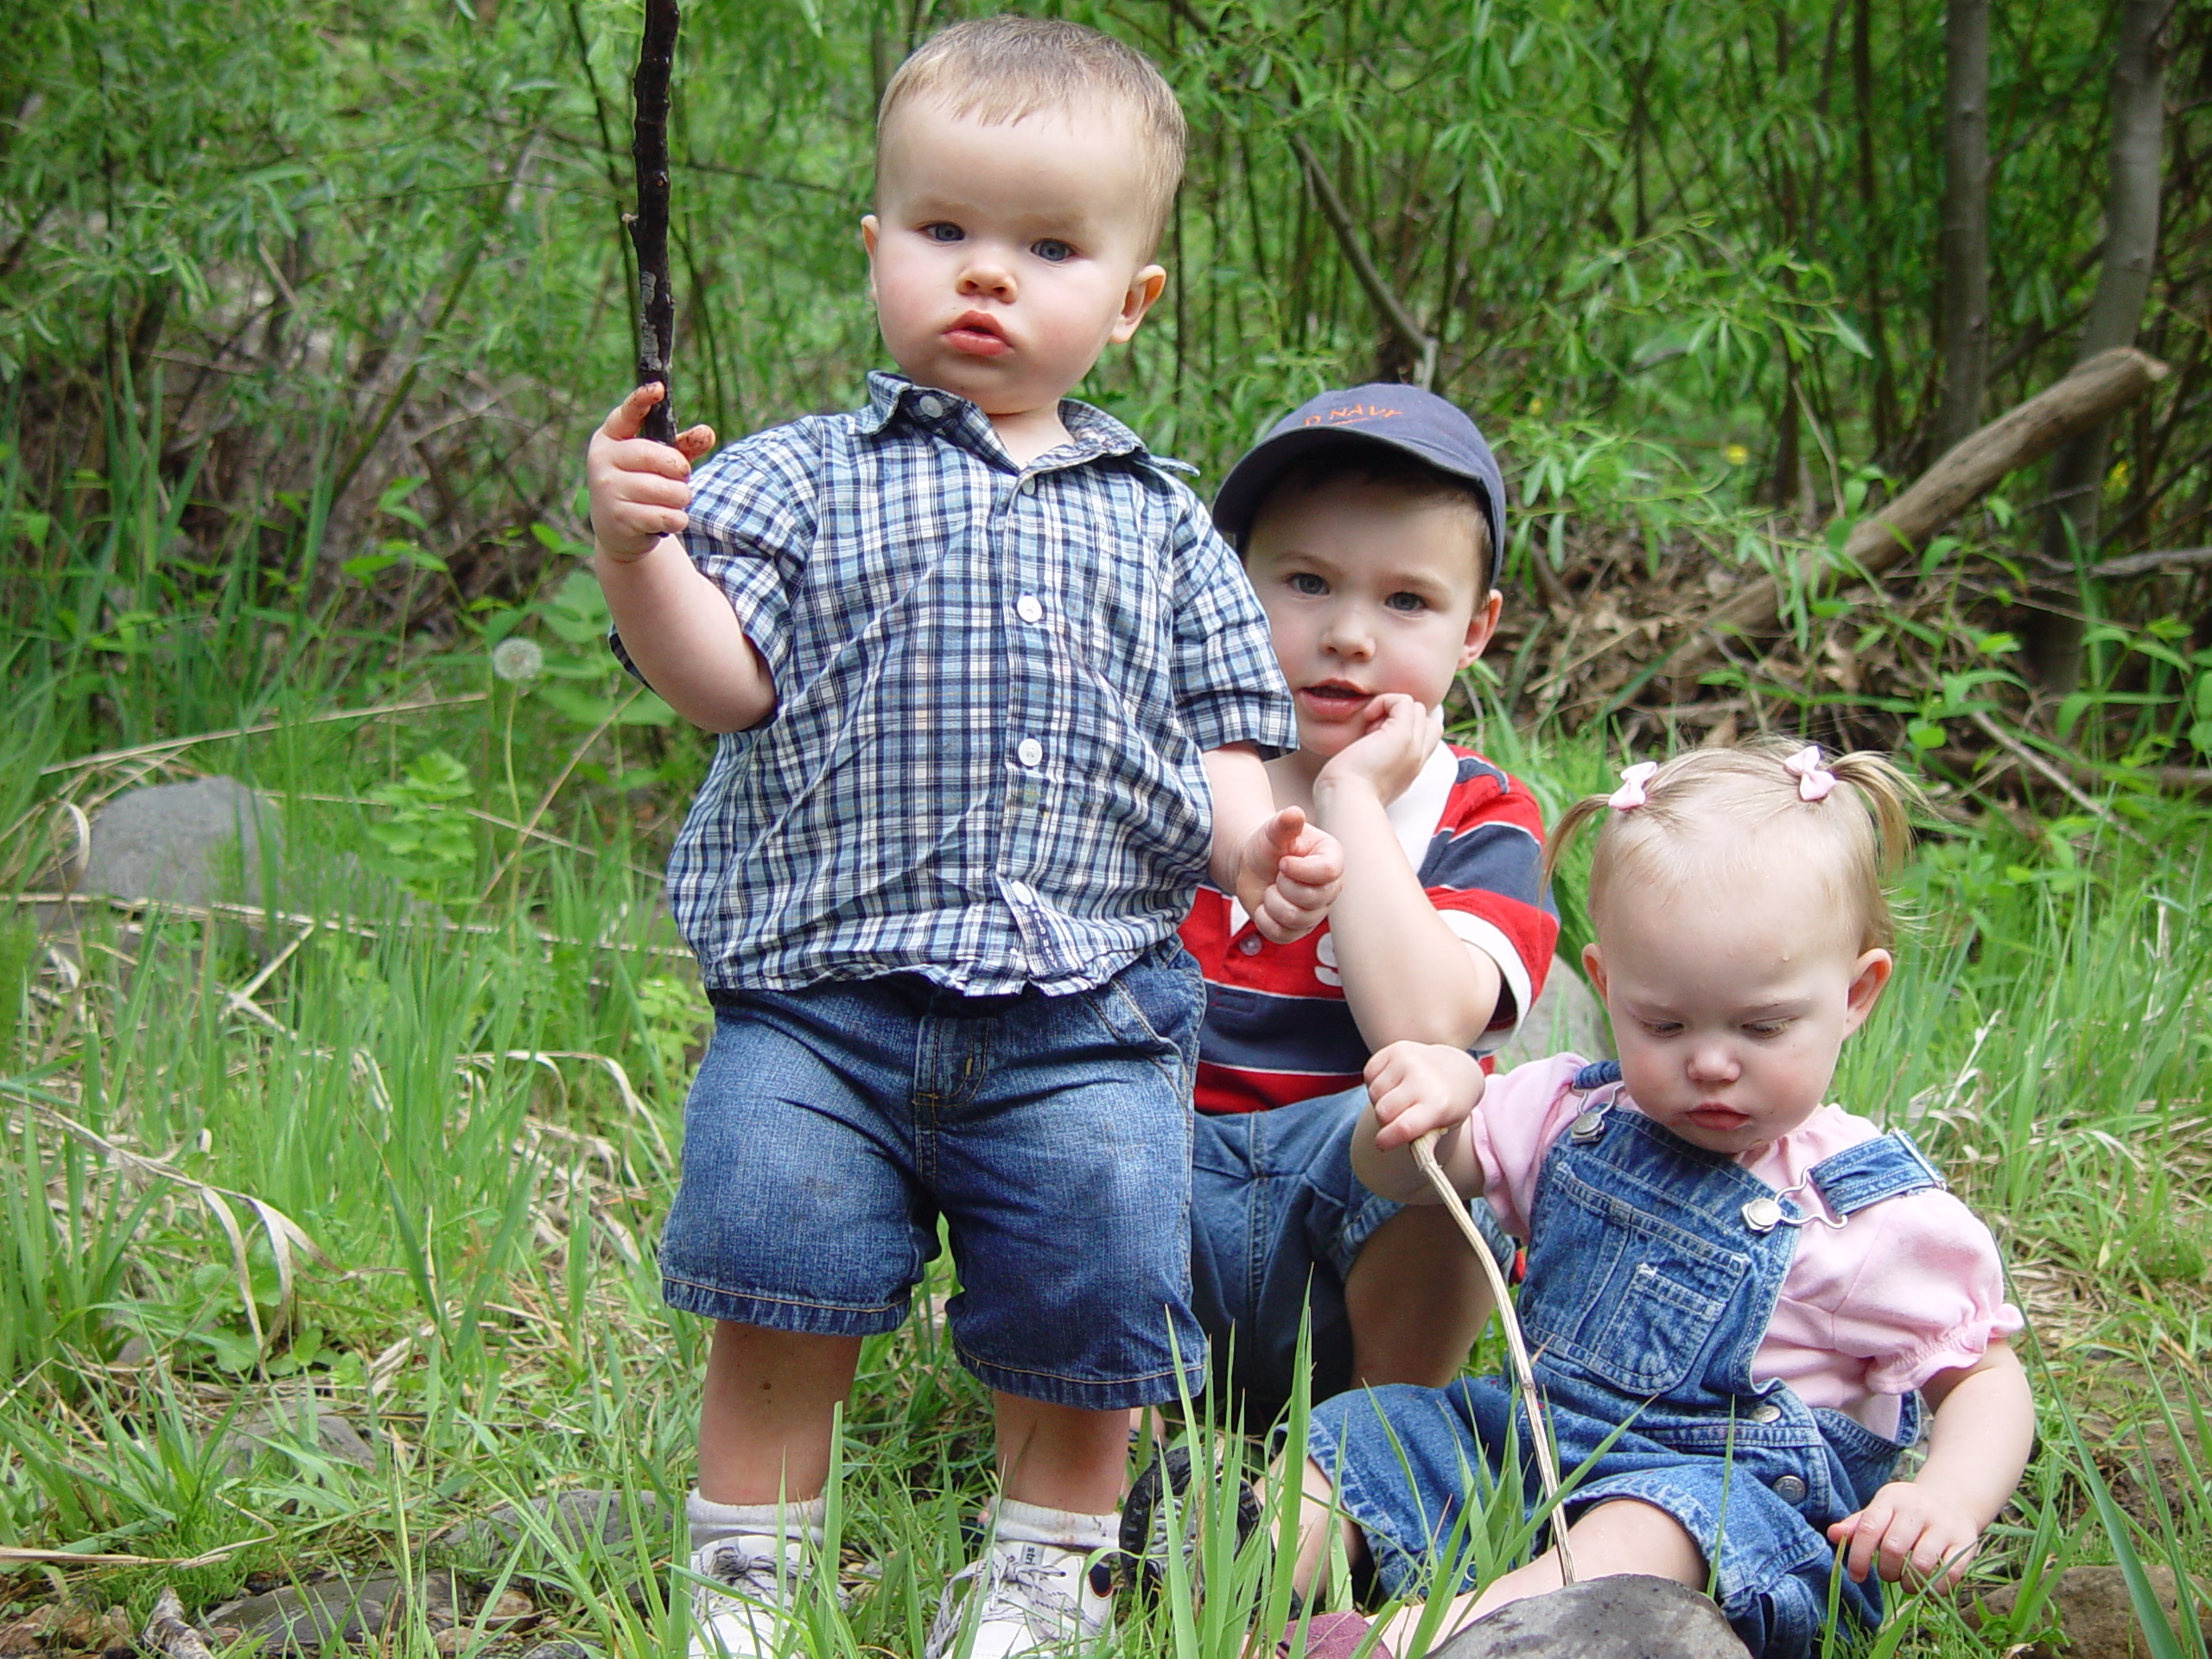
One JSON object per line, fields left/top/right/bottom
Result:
{"left": 661, "top": 940, "right": 1205, "bottom": 1411}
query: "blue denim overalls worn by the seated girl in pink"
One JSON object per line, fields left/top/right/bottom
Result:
{"left": 1307, "top": 1062, "right": 1942, "bottom": 1659}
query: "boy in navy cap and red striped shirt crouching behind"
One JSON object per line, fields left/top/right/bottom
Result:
{"left": 1184, "top": 385, "right": 1560, "bottom": 1414}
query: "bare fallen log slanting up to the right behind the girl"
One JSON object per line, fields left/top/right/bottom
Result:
{"left": 1666, "top": 345, "right": 2168, "bottom": 675}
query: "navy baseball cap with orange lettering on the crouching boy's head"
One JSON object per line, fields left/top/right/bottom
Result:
{"left": 1214, "top": 383, "right": 1506, "bottom": 588}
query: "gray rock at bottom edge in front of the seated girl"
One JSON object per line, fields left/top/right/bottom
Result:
{"left": 1433, "top": 1577, "right": 1750, "bottom": 1659}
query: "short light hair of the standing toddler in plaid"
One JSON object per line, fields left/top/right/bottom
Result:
{"left": 876, "top": 16, "right": 1188, "bottom": 254}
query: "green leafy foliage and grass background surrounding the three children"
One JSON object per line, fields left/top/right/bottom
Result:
{"left": 0, "top": 0, "right": 2212, "bottom": 1659}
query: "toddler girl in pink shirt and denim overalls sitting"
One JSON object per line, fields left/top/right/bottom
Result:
{"left": 1299, "top": 743, "right": 2033, "bottom": 1656}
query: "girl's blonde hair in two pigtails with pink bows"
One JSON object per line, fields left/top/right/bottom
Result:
{"left": 1544, "top": 736, "right": 1927, "bottom": 951}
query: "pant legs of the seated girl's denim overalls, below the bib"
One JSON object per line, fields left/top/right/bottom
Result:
{"left": 1307, "top": 1378, "right": 1918, "bottom": 1659}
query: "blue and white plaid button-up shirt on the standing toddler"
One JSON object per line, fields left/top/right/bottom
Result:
{"left": 615, "top": 374, "right": 1299, "bottom": 995}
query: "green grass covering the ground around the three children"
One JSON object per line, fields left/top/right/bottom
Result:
{"left": 0, "top": 448, "right": 2212, "bottom": 1659}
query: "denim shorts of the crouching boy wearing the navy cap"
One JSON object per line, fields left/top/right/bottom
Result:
{"left": 1190, "top": 1089, "right": 1513, "bottom": 1429}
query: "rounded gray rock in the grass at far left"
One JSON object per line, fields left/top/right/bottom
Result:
{"left": 78, "top": 779, "right": 281, "bottom": 905}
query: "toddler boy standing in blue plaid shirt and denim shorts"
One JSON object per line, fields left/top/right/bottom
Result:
{"left": 588, "top": 17, "right": 1340, "bottom": 1659}
